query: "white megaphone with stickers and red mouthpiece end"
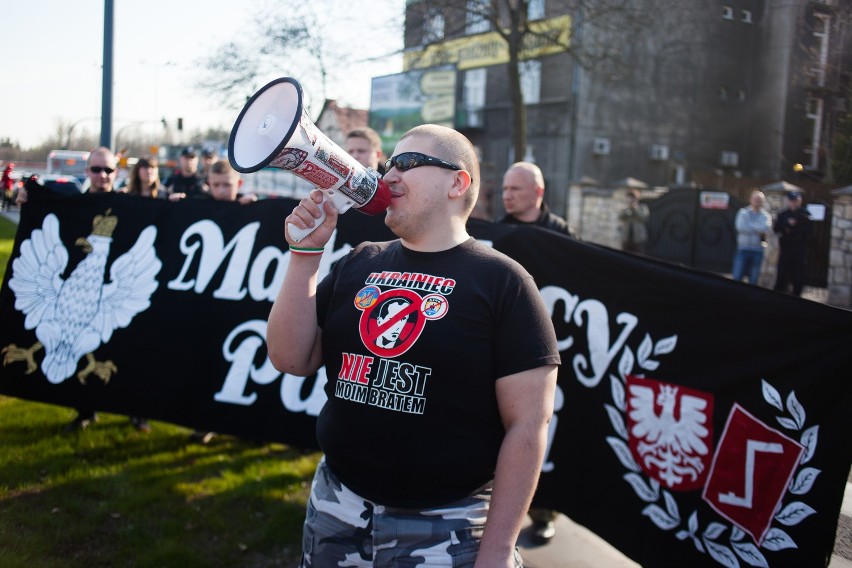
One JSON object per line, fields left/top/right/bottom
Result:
{"left": 228, "top": 77, "right": 390, "bottom": 243}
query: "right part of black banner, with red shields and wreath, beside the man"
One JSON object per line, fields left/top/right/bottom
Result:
{"left": 480, "top": 222, "right": 852, "bottom": 567}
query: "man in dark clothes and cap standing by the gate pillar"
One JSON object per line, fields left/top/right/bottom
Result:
{"left": 772, "top": 191, "right": 811, "bottom": 296}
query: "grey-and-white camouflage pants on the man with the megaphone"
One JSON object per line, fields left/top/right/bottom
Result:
{"left": 301, "top": 459, "right": 523, "bottom": 568}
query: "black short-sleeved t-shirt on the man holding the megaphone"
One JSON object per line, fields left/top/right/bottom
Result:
{"left": 317, "top": 235, "right": 559, "bottom": 507}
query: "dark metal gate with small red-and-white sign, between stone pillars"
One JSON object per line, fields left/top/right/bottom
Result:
{"left": 645, "top": 187, "right": 745, "bottom": 273}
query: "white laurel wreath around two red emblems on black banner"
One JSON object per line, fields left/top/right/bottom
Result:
{"left": 604, "top": 334, "right": 821, "bottom": 568}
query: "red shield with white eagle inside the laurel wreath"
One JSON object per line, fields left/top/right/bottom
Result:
{"left": 627, "top": 376, "right": 713, "bottom": 491}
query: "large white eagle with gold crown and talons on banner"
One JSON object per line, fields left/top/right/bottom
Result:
{"left": 2, "top": 211, "right": 162, "bottom": 384}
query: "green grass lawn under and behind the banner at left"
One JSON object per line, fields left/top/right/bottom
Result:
{"left": 0, "top": 218, "right": 319, "bottom": 568}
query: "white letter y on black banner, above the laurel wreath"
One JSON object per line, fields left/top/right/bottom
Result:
{"left": 574, "top": 300, "right": 639, "bottom": 388}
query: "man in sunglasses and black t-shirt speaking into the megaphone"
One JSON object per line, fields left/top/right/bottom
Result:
{"left": 267, "top": 125, "right": 560, "bottom": 568}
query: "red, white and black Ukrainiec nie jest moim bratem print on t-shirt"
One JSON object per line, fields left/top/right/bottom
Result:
{"left": 334, "top": 272, "right": 455, "bottom": 414}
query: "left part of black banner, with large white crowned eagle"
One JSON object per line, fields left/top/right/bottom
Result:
{"left": 0, "top": 194, "right": 393, "bottom": 448}
